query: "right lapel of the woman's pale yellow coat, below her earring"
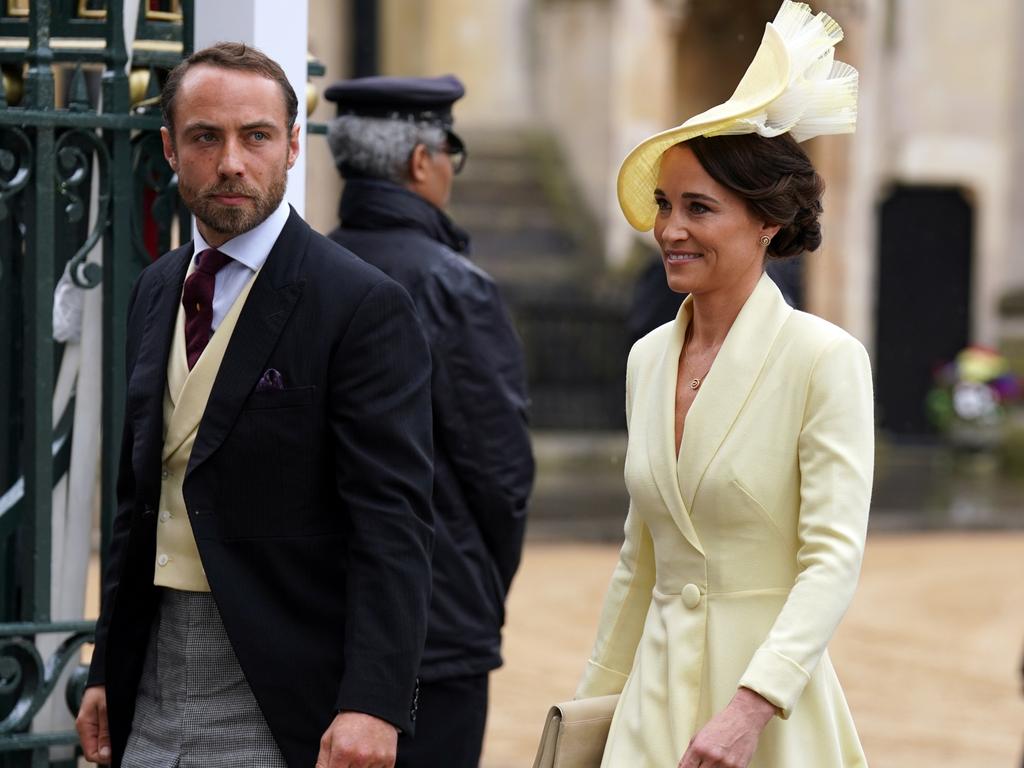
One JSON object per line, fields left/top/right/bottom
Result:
{"left": 679, "top": 274, "right": 793, "bottom": 511}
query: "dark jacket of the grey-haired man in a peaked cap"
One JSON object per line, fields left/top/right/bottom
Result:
{"left": 330, "top": 179, "right": 534, "bottom": 682}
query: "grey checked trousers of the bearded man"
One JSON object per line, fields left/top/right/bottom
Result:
{"left": 122, "top": 589, "right": 287, "bottom": 768}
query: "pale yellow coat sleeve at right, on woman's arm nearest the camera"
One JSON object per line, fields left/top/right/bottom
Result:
{"left": 739, "top": 336, "right": 874, "bottom": 718}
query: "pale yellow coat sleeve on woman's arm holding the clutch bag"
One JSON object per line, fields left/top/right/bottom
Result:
{"left": 575, "top": 347, "right": 654, "bottom": 698}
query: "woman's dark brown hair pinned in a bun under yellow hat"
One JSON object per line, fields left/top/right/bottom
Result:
{"left": 685, "top": 133, "right": 824, "bottom": 259}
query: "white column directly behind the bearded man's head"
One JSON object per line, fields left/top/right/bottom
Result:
{"left": 196, "top": 0, "right": 309, "bottom": 214}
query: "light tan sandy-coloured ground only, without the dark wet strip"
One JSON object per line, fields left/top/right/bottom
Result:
{"left": 481, "top": 531, "right": 1024, "bottom": 768}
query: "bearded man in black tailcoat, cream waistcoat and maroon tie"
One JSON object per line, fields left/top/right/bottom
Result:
{"left": 77, "top": 43, "right": 432, "bottom": 768}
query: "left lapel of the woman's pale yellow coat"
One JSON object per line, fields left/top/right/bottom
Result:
{"left": 646, "top": 298, "right": 703, "bottom": 554}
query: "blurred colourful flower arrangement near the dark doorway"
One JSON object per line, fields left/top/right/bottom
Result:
{"left": 927, "top": 346, "right": 1024, "bottom": 447}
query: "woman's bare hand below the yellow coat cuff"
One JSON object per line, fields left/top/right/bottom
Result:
{"left": 679, "top": 688, "right": 776, "bottom": 768}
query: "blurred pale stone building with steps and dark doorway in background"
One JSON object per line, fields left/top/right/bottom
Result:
{"left": 307, "top": 0, "right": 1024, "bottom": 448}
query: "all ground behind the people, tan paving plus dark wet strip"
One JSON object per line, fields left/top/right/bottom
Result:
{"left": 481, "top": 432, "right": 1024, "bottom": 768}
